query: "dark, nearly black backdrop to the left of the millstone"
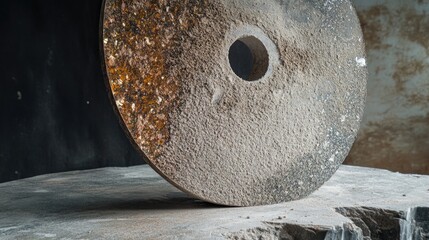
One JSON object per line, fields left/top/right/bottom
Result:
{"left": 0, "top": 0, "right": 144, "bottom": 182}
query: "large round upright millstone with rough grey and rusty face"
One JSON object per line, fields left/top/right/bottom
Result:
{"left": 102, "top": 0, "right": 367, "bottom": 206}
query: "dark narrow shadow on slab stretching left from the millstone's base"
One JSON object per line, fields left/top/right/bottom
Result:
{"left": 2, "top": 191, "right": 217, "bottom": 218}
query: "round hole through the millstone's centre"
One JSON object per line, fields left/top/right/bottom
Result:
{"left": 228, "top": 36, "right": 269, "bottom": 81}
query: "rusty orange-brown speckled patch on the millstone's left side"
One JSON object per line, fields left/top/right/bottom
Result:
{"left": 103, "top": 0, "right": 206, "bottom": 159}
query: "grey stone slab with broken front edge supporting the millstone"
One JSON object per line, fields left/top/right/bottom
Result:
{"left": 0, "top": 166, "right": 429, "bottom": 240}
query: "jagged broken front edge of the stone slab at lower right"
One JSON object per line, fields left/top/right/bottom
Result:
{"left": 227, "top": 207, "right": 429, "bottom": 240}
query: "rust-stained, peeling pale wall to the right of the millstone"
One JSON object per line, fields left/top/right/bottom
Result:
{"left": 346, "top": 0, "right": 429, "bottom": 174}
